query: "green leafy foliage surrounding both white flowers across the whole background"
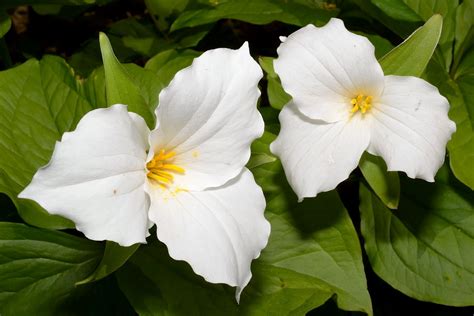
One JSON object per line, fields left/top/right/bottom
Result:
{"left": 0, "top": 0, "right": 474, "bottom": 315}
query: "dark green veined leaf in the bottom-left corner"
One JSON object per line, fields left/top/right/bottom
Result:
{"left": 0, "top": 222, "right": 102, "bottom": 316}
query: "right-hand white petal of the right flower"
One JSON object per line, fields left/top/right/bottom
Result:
{"left": 368, "top": 76, "right": 456, "bottom": 181}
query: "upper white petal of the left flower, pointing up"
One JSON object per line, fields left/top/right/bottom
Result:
{"left": 150, "top": 43, "right": 264, "bottom": 190}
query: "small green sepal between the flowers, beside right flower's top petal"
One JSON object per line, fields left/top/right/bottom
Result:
{"left": 258, "top": 57, "right": 291, "bottom": 110}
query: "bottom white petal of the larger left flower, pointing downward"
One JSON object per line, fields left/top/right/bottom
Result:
{"left": 144, "top": 169, "right": 270, "bottom": 300}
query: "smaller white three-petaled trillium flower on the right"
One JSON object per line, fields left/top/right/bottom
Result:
{"left": 271, "top": 19, "right": 456, "bottom": 200}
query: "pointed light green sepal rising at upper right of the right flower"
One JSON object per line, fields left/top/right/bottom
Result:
{"left": 380, "top": 15, "right": 443, "bottom": 77}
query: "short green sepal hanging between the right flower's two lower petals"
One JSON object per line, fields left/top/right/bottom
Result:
{"left": 359, "top": 153, "right": 400, "bottom": 209}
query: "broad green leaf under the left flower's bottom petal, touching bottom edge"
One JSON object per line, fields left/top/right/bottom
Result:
{"left": 117, "top": 238, "right": 331, "bottom": 316}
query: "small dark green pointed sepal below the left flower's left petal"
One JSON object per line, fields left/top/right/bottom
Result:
{"left": 76, "top": 241, "right": 140, "bottom": 285}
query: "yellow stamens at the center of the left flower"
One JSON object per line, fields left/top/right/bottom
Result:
{"left": 146, "top": 149, "right": 184, "bottom": 189}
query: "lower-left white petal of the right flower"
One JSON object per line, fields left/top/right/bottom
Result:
{"left": 270, "top": 102, "right": 370, "bottom": 201}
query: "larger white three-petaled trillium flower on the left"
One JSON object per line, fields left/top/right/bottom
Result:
{"left": 19, "top": 44, "right": 270, "bottom": 299}
